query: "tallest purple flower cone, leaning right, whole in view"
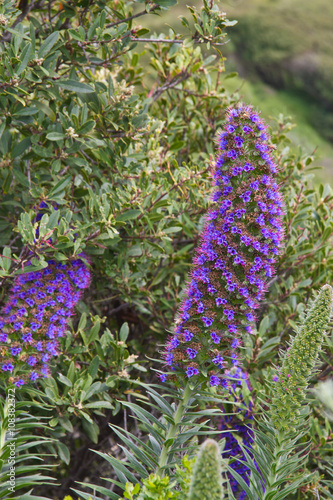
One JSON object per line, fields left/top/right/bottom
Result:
{"left": 161, "top": 105, "right": 283, "bottom": 386}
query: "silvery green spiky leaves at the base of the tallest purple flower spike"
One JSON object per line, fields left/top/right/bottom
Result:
{"left": 74, "top": 384, "right": 228, "bottom": 500}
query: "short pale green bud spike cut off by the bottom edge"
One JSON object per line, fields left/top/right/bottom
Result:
{"left": 187, "top": 439, "right": 224, "bottom": 500}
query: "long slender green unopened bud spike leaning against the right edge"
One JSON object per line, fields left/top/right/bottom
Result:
{"left": 270, "top": 285, "right": 333, "bottom": 431}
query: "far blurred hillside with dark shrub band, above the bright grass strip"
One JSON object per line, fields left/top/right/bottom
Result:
{"left": 223, "top": 0, "right": 333, "bottom": 142}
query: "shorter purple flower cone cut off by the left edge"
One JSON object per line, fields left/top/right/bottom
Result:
{"left": 0, "top": 259, "right": 90, "bottom": 387}
